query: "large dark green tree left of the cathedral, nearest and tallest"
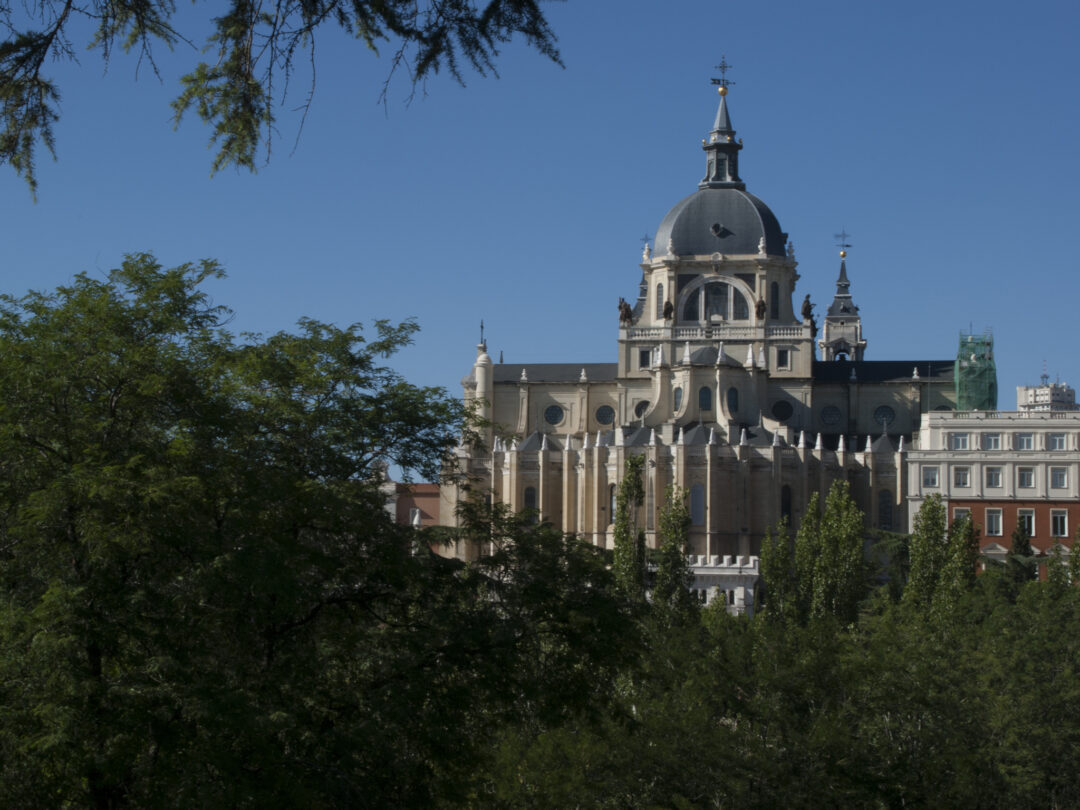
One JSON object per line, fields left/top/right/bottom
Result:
{"left": 0, "top": 255, "right": 634, "bottom": 807}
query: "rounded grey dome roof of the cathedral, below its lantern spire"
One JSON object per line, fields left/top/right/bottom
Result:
{"left": 653, "top": 188, "right": 787, "bottom": 258}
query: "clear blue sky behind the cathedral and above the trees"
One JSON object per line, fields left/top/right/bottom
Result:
{"left": 0, "top": 0, "right": 1080, "bottom": 409}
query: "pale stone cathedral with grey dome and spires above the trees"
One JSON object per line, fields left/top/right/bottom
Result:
{"left": 441, "top": 81, "right": 957, "bottom": 578}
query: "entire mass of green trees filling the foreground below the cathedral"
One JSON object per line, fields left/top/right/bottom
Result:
{"left": 0, "top": 264, "right": 1080, "bottom": 810}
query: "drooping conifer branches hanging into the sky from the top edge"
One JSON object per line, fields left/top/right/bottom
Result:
{"left": 0, "top": 0, "right": 559, "bottom": 190}
